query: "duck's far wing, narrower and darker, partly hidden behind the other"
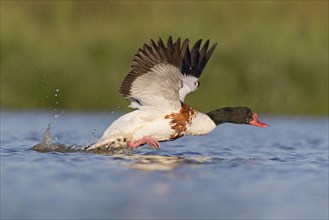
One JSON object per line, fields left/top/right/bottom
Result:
{"left": 179, "top": 39, "right": 217, "bottom": 102}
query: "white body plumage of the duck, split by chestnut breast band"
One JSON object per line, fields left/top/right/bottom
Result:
{"left": 89, "top": 109, "right": 216, "bottom": 149}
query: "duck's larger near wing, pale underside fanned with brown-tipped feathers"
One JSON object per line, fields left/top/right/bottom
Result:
{"left": 120, "top": 37, "right": 188, "bottom": 109}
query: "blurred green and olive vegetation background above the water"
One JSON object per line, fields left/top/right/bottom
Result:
{"left": 1, "top": 1, "right": 328, "bottom": 115}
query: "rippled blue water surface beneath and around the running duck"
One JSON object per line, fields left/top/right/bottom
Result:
{"left": 0, "top": 111, "right": 328, "bottom": 219}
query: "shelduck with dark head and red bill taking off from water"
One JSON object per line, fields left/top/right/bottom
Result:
{"left": 88, "top": 36, "right": 269, "bottom": 150}
